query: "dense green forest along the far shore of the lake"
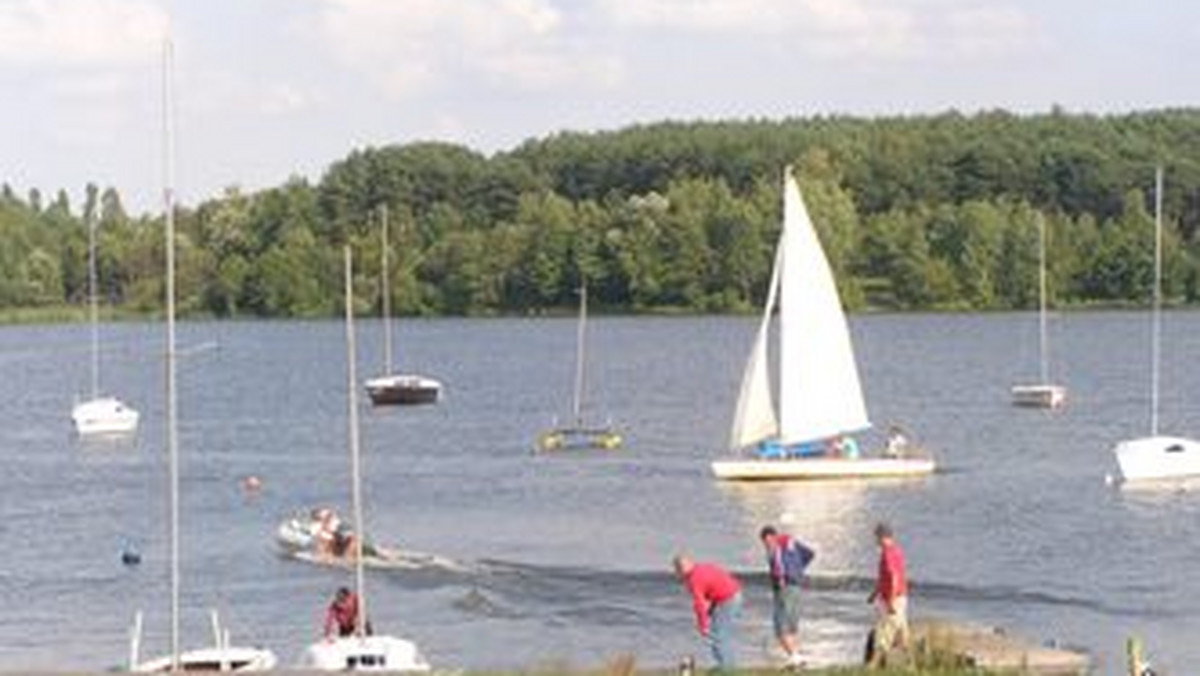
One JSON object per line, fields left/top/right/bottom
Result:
{"left": 0, "top": 109, "right": 1200, "bottom": 317}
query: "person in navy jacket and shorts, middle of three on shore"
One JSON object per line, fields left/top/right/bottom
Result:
{"left": 758, "top": 525, "right": 815, "bottom": 669}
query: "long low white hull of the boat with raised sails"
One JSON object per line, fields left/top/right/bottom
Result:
{"left": 712, "top": 457, "right": 937, "bottom": 480}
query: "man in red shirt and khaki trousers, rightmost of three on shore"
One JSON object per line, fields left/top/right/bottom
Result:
{"left": 866, "top": 522, "right": 908, "bottom": 666}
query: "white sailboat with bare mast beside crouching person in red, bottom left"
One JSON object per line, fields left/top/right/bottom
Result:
{"left": 300, "top": 246, "right": 430, "bottom": 672}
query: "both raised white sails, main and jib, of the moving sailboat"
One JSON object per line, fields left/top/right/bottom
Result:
{"left": 731, "top": 169, "right": 870, "bottom": 448}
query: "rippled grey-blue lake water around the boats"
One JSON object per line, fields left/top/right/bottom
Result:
{"left": 0, "top": 312, "right": 1200, "bottom": 674}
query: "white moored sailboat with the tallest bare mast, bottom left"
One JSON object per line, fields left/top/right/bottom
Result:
{"left": 130, "top": 40, "right": 278, "bottom": 672}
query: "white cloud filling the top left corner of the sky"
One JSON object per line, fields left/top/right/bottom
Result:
{"left": 0, "top": 0, "right": 168, "bottom": 68}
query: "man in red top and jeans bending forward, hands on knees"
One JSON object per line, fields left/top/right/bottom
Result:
{"left": 673, "top": 554, "right": 742, "bottom": 672}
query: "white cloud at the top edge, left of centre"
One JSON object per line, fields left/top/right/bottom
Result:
{"left": 297, "top": 0, "right": 619, "bottom": 96}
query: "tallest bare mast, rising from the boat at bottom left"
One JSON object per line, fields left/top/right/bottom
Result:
{"left": 162, "top": 36, "right": 179, "bottom": 671}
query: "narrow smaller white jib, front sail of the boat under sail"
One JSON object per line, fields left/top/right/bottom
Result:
{"left": 730, "top": 243, "right": 784, "bottom": 449}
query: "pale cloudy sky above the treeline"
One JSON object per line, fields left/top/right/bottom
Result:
{"left": 0, "top": 0, "right": 1200, "bottom": 213}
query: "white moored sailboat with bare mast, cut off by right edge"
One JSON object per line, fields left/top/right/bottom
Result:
{"left": 1112, "top": 167, "right": 1200, "bottom": 484}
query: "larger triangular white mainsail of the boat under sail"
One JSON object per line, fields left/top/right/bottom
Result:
{"left": 779, "top": 169, "right": 871, "bottom": 443}
